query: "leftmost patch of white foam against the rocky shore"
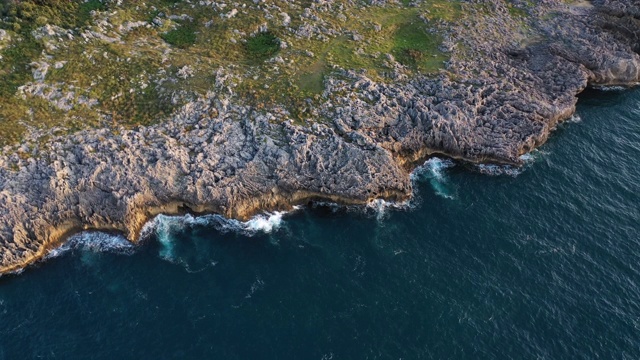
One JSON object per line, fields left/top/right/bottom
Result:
{"left": 46, "top": 231, "right": 136, "bottom": 258}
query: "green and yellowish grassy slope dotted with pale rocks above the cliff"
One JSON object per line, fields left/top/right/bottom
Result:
{"left": 0, "top": 0, "right": 464, "bottom": 145}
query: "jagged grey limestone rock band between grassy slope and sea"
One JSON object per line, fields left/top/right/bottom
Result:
{"left": 0, "top": 0, "right": 640, "bottom": 273}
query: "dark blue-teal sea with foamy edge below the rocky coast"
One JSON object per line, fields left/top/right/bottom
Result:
{"left": 0, "top": 90, "right": 640, "bottom": 360}
